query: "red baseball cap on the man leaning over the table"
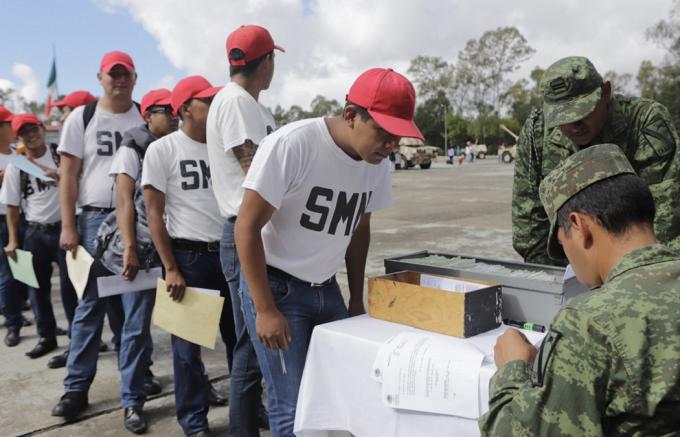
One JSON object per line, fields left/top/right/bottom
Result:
{"left": 347, "top": 68, "right": 425, "bottom": 141}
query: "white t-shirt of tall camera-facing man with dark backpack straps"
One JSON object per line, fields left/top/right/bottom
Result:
{"left": 57, "top": 105, "right": 144, "bottom": 208}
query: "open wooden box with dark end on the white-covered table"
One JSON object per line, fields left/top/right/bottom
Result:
{"left": 368, "top": 271, "right": 502, "bottom": 338}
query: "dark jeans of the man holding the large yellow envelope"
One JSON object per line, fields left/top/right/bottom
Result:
{"left": 171, "top": 250, "right": 236, "bottom": 435}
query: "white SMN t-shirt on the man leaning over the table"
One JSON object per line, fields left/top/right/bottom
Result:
{"left": 243, "top": 118, "right": 392, "bottom": 282}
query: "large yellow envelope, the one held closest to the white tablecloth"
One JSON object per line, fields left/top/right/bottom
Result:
{"left": 152, "top": 278, "right": 224, "bottom": 349}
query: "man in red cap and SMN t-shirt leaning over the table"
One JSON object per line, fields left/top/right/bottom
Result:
{"left": 236, "top": 68, "right": 423, "bottom": 436}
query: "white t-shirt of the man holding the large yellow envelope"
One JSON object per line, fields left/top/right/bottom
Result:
{"left": 142, "top": 129, "right": 224, "bottom": 241}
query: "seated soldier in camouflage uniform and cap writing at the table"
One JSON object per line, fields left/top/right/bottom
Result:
{"left": 479, "top": 144, "right": 680, "bottom": 437}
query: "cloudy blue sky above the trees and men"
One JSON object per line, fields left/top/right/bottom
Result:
{"left": 0, "top": 0, "right": 674, "bottom": 108}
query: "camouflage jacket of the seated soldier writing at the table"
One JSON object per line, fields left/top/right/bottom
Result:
{"left": 479, "top": 244, "right": 680, "bottom": 437}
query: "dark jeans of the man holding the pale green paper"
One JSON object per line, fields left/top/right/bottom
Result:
{"left": 24, "top": 224, "right": 78, "bottom": 338}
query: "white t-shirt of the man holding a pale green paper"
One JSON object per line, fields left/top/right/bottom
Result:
{"left": 0, "top": 146, "right": 61, "bottom": 225}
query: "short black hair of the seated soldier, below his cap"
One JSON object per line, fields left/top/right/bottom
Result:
{"left": 557, "top": 174, "right": 656, "bottom": 236}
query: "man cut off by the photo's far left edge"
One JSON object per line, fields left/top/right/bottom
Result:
{"left": 0, "top": 105, "right": 23, "bottom": 347}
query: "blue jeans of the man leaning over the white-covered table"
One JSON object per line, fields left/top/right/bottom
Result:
{"left": 241, "top": 275, "right": 348, "bottom": 437}
